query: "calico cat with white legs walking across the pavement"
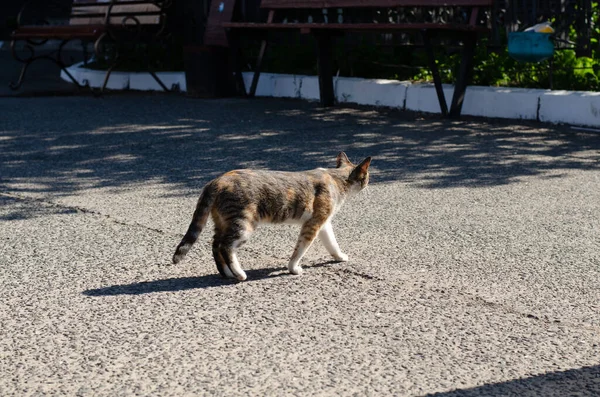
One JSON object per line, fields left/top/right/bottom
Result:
{"left": 173, "top": 152, "right": 371, "bottom": 281}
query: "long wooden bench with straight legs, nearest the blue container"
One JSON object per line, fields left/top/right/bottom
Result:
{"left": 222, "top": 0, "right": 493, "bottom": 118}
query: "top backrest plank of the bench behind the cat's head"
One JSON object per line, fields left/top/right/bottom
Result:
{"left": 260, "top": 0, "right": 493, "bottom": 9}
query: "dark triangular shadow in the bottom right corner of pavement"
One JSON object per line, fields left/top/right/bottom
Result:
{"left": 427, "top": 366, "right": 600, "bottom": 397}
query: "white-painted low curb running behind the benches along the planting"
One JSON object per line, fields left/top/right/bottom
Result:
{"left": 61, "top": 64, "right": 600, "bottom": 127}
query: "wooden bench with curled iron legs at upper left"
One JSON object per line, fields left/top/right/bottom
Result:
{"left": 10, "top": 0, "right": 171, "bottom": 92}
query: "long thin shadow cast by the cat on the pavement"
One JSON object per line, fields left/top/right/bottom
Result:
{"left": 82, "top": 261, "right": 338, "bottom": 296}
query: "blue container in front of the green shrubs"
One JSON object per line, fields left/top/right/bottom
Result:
{"left": 508, "top": 32, "right": 554, "bottom": 62}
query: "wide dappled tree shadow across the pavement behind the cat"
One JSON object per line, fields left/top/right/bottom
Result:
{"left": 0, "top": 95, "right": 600, "bottom": 218}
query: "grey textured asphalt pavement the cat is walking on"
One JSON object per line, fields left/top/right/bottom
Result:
{"left": 0, "top": 95, "right": 600, "bottom": 397}
